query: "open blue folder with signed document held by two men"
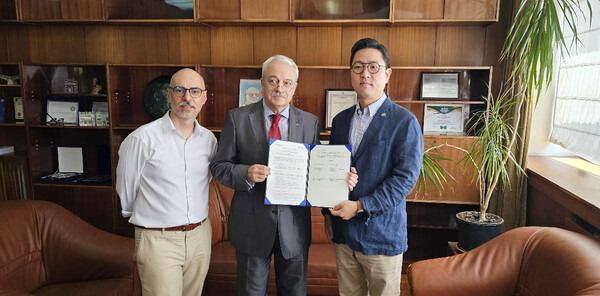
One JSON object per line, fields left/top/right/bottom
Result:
{"left": 265, "top": 139, "right": 352, "bottom": 207}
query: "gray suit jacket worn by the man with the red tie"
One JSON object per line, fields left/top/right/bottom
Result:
{"left": 210, "top": 101, "right": 320, "bottom": 259}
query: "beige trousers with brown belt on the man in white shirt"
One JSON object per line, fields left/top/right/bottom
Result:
{"left": 135, "top": 219, "right": 212, "bottom": 296}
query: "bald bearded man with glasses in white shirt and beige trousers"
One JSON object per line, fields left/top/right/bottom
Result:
{"left": 116, "top": 68, "right": 217, "bottom": 296}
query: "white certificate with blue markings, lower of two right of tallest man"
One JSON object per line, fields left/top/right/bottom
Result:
{"left": 423, "top": 104, "right": 469, "bottom": 136}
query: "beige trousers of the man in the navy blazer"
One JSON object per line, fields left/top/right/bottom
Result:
{"left": 334, "top": 244, "right": 402, "bottom": 296}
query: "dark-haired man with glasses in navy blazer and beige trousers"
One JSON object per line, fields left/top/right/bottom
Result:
{"left": 323, "top": 38, "right": 423, "bottom": 295}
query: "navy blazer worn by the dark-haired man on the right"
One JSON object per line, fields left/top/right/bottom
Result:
{"left": 324, "top": 97, "right": 423, "bottom": 256}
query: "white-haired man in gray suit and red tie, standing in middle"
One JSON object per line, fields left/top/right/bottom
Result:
{"left": 210, "top": 55, "right": 357, "bottom": 296}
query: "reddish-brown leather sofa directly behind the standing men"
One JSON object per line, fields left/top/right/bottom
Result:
{"left": 203, "top": 180, "right": 338, "bottom": 295}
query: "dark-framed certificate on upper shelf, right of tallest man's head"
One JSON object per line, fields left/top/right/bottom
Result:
{"left": 421, "top": 72, "right": 459, "bottom": 100}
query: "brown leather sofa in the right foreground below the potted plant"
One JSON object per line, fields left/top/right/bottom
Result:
{"left": 408, "top": 227, "right": 600, "bottom": 296}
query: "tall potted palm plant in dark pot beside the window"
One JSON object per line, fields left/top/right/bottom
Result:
{"left": 457, "top": 0, "right": 591, "bottom": 250}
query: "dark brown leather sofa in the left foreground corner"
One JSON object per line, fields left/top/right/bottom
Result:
{"left": 0, "top": 200, "right": 141, "bottom": 296}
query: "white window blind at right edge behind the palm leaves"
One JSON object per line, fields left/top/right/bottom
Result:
{"left": 550, "top": 1, "right": 600, "bottom": 164}
